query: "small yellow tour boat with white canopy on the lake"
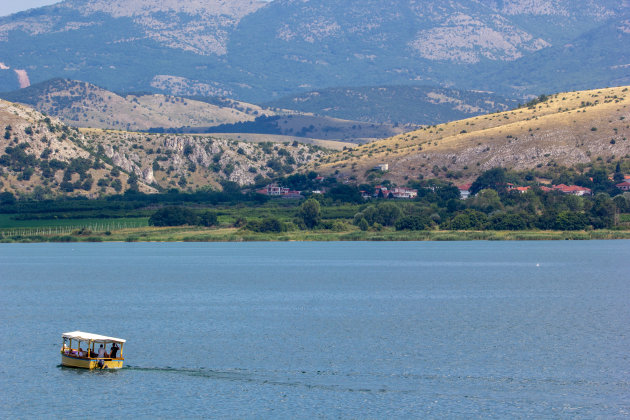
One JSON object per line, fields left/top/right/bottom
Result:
{"left": 61, "top": 331, "right": 125, "bottom": 369}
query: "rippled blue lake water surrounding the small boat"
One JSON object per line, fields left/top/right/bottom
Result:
{"left": 0, "top": 241, "right": 630, "bottom": 418}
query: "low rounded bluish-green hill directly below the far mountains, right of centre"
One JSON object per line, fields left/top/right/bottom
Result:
{"left": 264, "top": 86, "right": 517, "bottom": 125}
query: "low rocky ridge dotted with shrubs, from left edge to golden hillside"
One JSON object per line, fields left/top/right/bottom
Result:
{"left": 0, "top": 100, "right": 331, "bottom": 199}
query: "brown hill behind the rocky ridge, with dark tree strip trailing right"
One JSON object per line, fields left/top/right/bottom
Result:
{"left": 0, "top": 79, "right": 410, "bottom": 146}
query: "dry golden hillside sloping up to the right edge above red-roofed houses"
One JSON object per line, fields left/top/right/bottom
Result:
{"left": 314, "top": 87, "right": 630, "bottom": 183}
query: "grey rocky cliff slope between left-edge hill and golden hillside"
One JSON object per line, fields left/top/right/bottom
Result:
{"left": 91, "top": 132, "right": 331, "bottom": 189}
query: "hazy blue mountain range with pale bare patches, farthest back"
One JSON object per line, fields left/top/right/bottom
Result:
{"left": 0, "top": 0, "right": 630, "bottom": 102}
